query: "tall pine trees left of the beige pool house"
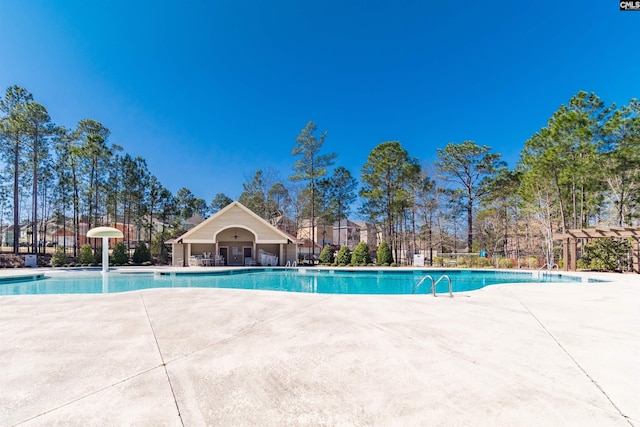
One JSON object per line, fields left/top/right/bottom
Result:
{"left": 0, "top": 86, "right": 192, "bottom": 257}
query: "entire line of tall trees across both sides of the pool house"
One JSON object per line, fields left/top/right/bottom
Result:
{"left": 0, "top": 86, "right": 640, "bottom": 262}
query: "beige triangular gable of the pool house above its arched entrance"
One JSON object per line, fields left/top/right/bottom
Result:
{"left": 175, "top": 201, "right": 298, "bottom": 243}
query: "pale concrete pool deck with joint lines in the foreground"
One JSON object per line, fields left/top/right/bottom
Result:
{"left": 0, "top": 271, "right": 640, "bottom": 426}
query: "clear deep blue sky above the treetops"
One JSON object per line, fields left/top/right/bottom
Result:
{"left": 0, "top": 0, "right": 640, "bottom": 202}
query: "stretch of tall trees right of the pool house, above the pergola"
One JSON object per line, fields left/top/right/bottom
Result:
{"left": 240, "top": 92, "right": 640, "bottom": 262}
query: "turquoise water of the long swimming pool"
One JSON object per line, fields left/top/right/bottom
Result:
{"left": 0, "top": 268, "right": 596, "bottom": 295}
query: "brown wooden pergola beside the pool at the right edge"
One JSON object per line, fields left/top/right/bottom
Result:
{"left": 553, "top": 227, "right": 640, "bottom": 273}
